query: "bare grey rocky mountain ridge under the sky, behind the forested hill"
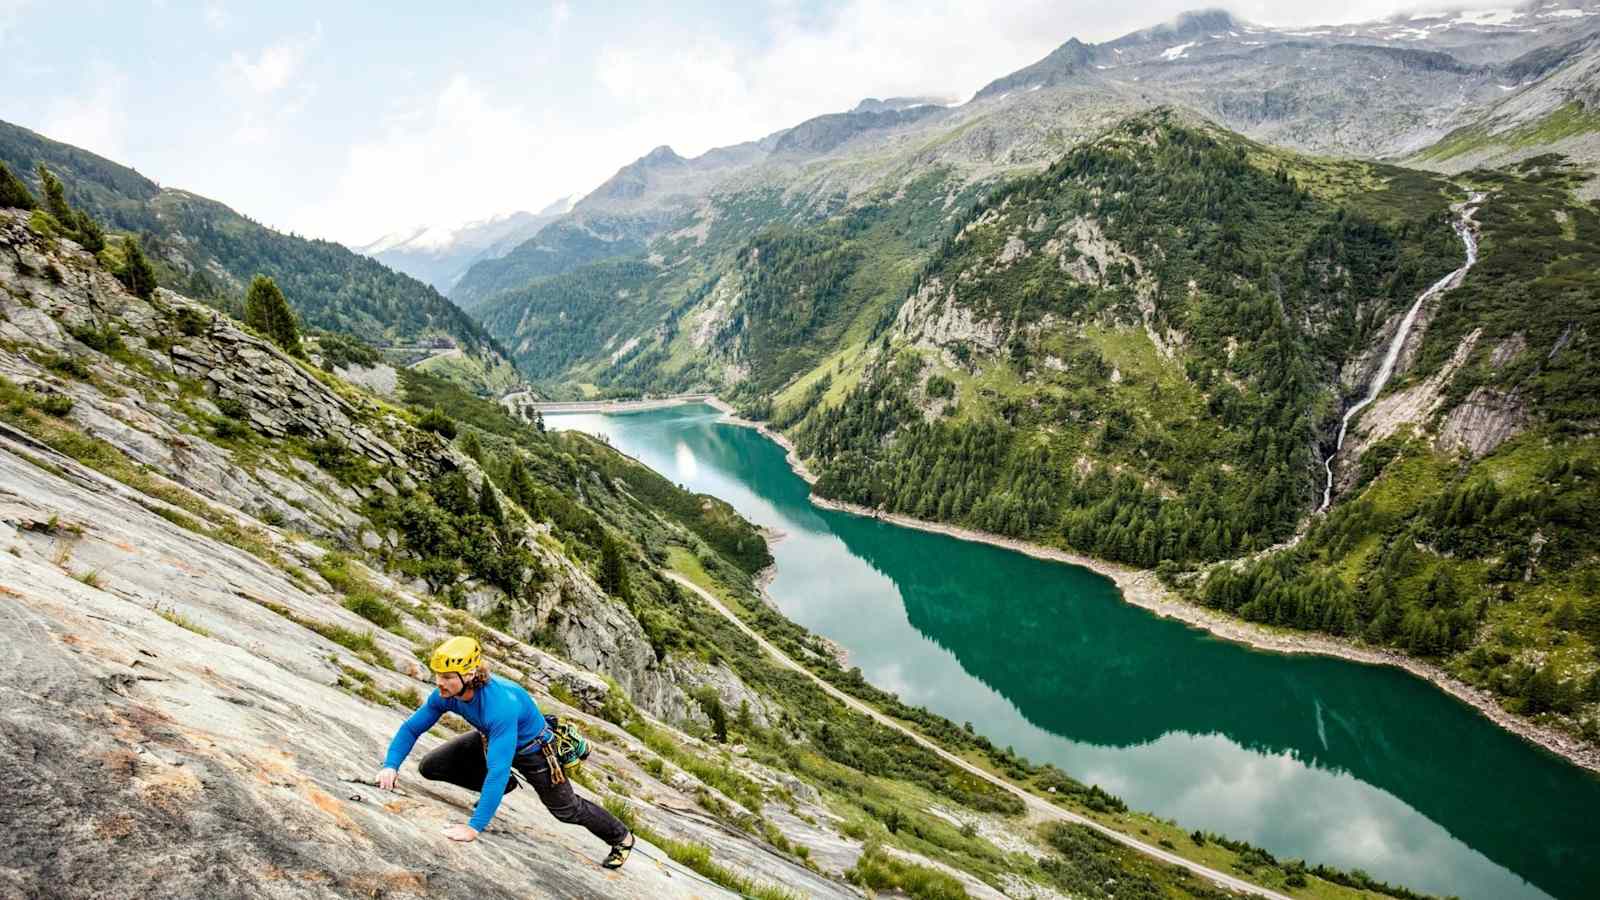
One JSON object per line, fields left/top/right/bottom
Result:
{"left": 451, "top": 0, "right": 1600, "bottom": 306}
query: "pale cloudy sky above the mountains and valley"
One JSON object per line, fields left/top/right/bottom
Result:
{"left": 0, "top": 0, "right": 1485, "bottom": 243}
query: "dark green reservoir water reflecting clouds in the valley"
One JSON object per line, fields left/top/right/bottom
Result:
{"left": 546, "top": 405, "right": 1600, "bottom": 900}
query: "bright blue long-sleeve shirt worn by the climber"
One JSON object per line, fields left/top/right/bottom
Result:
{"left": 384, "top": 677, "right": 544, "bottom": 831}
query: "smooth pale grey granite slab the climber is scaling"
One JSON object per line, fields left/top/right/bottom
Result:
{"left": 0, "top": 429, "right": 859, "bottom": 900}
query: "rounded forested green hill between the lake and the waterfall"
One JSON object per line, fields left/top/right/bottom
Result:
{"left": 796, "top": 115, "right": 1459, "bottom": 565}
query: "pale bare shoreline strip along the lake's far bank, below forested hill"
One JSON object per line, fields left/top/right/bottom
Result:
{"left": 704, "top": 405, "right": 1600, "bottom": 773}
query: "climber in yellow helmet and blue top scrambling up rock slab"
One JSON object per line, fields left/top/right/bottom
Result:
{"left": 378, "top": 637, "right": 634, "bottom": 868}
